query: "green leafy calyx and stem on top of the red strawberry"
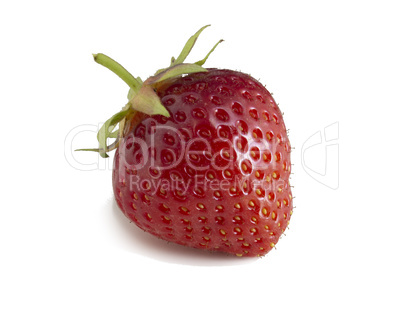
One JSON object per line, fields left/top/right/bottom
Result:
{"left": 76, "top": 25, "right": 223, "bottom": 158}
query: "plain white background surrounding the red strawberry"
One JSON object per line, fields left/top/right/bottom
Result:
{"left": 0, "top": 0, "right": 402, "bottom": 313}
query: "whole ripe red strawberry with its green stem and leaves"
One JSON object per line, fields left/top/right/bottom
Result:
{"left": 77, "top": 27, "right": 292, "bottom": 257}
